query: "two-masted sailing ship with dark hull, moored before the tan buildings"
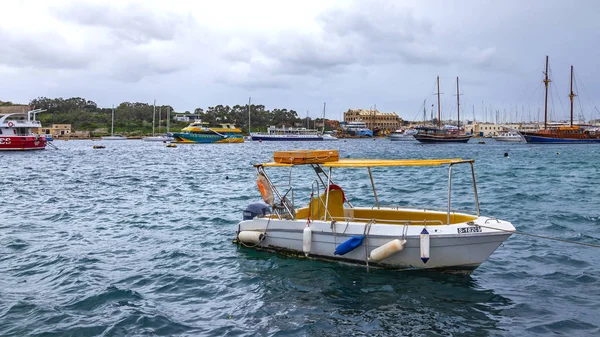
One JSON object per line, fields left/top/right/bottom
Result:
{"left": 413, "top": 76, "right": 471, "bottom": 143}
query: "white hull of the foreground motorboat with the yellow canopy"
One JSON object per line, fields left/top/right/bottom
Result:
{"left": 238, "top": 209, "right": 515, "bottom": 273}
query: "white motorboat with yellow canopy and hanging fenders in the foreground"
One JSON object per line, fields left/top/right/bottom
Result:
{"left": 235, "top": 150, "right": 515, "bottom": 273}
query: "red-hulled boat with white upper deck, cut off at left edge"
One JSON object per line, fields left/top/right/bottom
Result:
{"left": 0, "top": 109, "right": 46, "bottom": 151}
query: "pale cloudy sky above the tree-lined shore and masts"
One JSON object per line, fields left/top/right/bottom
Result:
{"left": 0, "top": 0, "right": 600, "bottom": 121}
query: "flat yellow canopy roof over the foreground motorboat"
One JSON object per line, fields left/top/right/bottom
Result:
{"left": 255, "top": 158, "right": 474, "bottom": 168}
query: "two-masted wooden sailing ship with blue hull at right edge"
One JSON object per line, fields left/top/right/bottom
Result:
{"left": 521, "top": 55, "right": 600, "bottom": 144}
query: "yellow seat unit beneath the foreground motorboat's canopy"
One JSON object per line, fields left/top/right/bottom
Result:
{"left": 296, "top": 185, "right": 346, "bottom": 220}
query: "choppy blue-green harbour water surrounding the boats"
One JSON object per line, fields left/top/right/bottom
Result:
{"left": 0, "top": 140, "right": 600, "bottom": 336}
